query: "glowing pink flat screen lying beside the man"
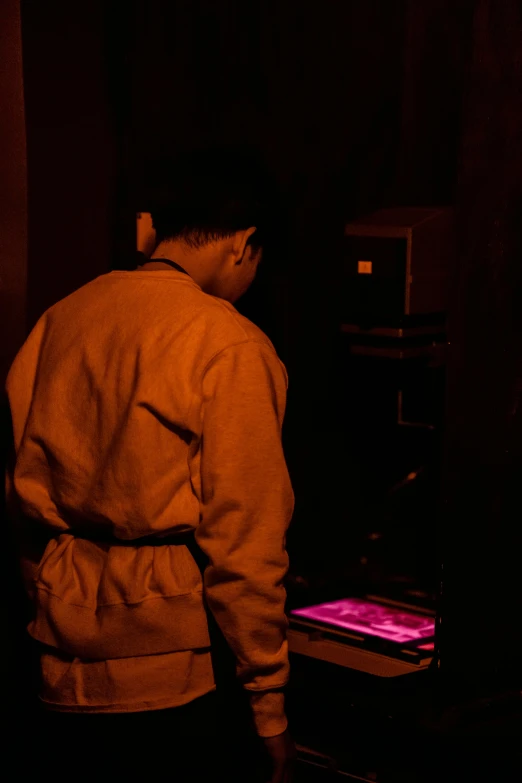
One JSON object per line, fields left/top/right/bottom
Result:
{"left": 291, "top": 598, "right": 435, "bottom": 644}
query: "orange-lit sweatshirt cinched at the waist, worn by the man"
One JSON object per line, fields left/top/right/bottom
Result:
{"left": 6, "top": 269, "right": 294, "bottom": 736}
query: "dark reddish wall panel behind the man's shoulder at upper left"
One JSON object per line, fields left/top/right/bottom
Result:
{"left": 20, "top": 0, "right": 116, "bottom": 328}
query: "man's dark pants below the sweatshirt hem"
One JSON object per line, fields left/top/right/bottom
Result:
{"left": 31, "top": 693, "right": 267, "bottom": 783}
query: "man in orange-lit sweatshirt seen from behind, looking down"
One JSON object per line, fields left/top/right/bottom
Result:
{"left": 7, "top": 150, "right": 294, "bottom": 783}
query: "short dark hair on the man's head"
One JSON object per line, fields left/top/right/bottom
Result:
{"left": 144, "top": 146, "right": 283, "bottom": 258}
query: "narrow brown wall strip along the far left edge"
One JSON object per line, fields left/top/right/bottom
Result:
{"left": 0, "top": 0, "right": 30, "bottom": 712}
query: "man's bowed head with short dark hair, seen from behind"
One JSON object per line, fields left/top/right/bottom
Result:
{"left": 144, "top": 147, "right": 279, "bottom": 302}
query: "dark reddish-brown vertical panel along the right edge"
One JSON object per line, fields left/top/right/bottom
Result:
{"left": 442, "top": 0, "right": 522, "bottom": 689}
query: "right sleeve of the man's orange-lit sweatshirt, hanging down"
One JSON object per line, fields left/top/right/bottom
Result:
{"left": 196, "top": 341, "right": 294, "bottom": 736}
